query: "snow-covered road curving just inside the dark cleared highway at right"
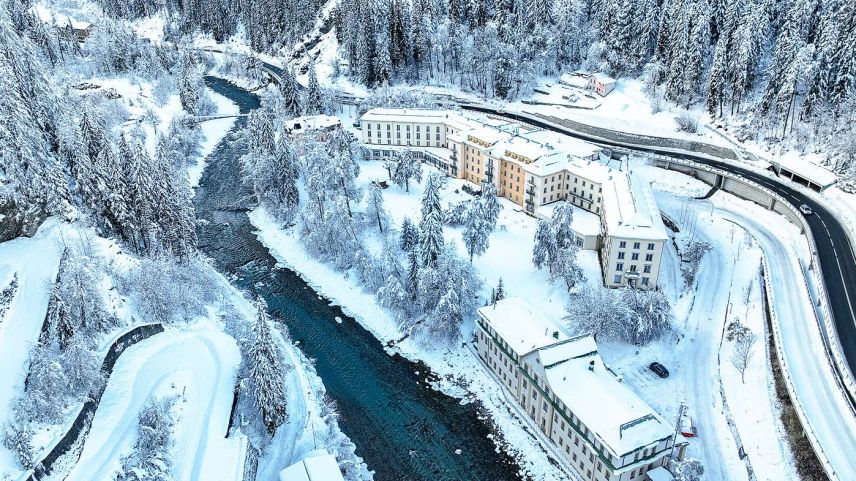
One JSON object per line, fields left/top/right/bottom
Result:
{"left": 716, "top": 197, "right": 856, "bottom": 480}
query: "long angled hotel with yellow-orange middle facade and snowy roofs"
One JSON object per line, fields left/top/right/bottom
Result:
{"left": 360, "top": 108, "right": 668, "bottom": 288}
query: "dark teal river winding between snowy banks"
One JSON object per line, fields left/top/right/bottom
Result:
{"left": 194, "top": 77, "right": 520, "bottom": 481}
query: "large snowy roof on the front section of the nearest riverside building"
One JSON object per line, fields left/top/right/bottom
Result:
{"left": 545, "top": 353, "right": 673, "bottom": 456}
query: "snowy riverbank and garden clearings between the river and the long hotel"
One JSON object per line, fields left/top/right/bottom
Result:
{"left": 250, "top": 162, "right": 600, "bottom": 480}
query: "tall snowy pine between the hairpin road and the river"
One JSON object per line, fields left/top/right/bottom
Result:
{"left": 247, "top": 297, "right": 287, "bottom": 434}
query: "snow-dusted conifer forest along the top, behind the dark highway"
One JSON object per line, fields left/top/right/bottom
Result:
{"left": 93, "top": 0, "right": 856, "bottom": 177}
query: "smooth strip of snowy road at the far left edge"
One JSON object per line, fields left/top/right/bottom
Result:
{"left": 0, "top": 219, "right": 62, "bottom": 478}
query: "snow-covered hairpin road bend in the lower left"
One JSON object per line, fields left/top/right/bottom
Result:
{"left": 66, "top": 327, "right": 243, "bottom": 481}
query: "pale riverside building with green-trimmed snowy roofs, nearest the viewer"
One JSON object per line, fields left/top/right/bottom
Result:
{"left": 476, "top": 298, "right": 686, "bottom": 481}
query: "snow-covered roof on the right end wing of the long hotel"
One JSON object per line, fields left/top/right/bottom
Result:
{"left": 603, "top": 171, "right": 669, "bottom": 240}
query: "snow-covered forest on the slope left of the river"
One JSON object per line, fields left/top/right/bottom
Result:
{"left": 0, "top": 1, "right": 366, "bottom": 481}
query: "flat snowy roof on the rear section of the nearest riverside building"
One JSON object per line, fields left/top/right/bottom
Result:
{"left": 478, "top": 297, "right": 570, "bottom": 356}
